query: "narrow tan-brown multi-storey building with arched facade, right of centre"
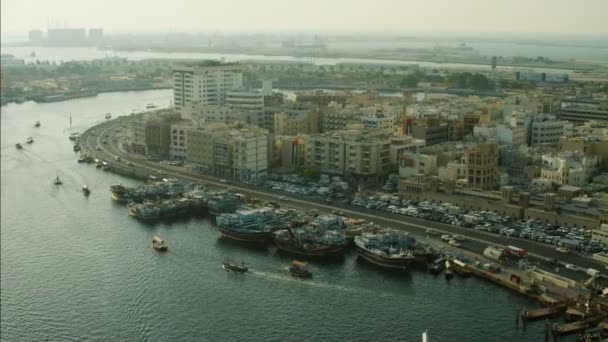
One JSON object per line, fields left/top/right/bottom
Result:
{"left": 464, "top": 142, "right": 498, "bottom": 190}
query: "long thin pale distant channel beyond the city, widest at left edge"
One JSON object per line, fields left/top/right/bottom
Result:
{"left": 2, "top": 46, "right": 588, "bottom": 74}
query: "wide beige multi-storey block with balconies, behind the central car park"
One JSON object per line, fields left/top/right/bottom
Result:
{"left": 305, "top": 124, "right": 392, "bottom": 177}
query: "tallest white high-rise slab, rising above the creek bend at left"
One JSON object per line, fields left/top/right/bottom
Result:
{"left": 173, "top": 61, "right": 243, "bottom": 110}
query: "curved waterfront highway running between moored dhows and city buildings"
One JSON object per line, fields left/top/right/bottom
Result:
{"left": 81, "top": 118, "right": 605, "bottom": 279}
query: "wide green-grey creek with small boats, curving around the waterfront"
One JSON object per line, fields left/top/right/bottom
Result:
{"left": 0, "top": 90, "right": 567, "bottom": 342}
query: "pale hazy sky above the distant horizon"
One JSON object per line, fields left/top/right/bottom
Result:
{"left": 0, "top": 0, "right": 608, "bottom": 35}
